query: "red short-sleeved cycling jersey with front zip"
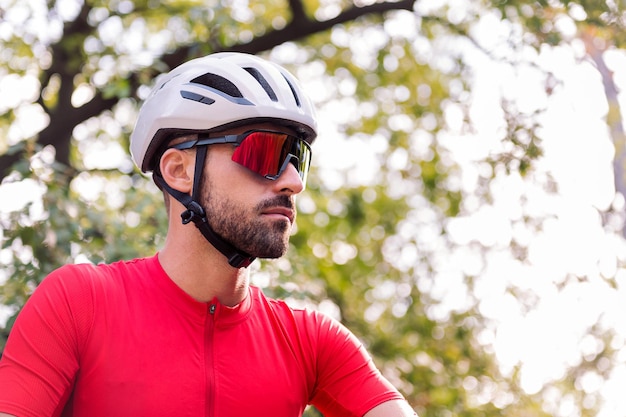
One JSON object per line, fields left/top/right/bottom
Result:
{"left": 0, "top": 256, "right": 402, "bottom": 417}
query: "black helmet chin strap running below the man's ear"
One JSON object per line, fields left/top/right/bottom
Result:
{"left": 153, "top": 146, "right": 256, "bottom": 268}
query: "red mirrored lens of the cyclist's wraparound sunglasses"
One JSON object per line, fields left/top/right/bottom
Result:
{"left": 232, "top": 131, "right": 311, "bottom": 181}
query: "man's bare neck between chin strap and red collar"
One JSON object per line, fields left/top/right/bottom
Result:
{"left": 159, "top": 224, "right": 249, "bottom": 307}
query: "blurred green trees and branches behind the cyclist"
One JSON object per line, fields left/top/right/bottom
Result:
{"left": 0, "top": 0, "right": 626, "bottom": 417}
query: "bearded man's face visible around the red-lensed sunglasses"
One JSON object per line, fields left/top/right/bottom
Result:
{"left": 195, "top": 125, "right": 303, "bottom": 258}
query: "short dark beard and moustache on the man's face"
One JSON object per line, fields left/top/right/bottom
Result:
{"left": 202, "top": 181, "right": 294, "bottom": 258}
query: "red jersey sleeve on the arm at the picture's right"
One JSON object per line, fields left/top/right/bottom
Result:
{"left": 311, "top": 313, "right": 403, "bottom": 417}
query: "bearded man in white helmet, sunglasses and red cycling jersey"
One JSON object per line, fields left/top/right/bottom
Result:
{"left": 0, "top": 53, "right": 415, "bottom": 417}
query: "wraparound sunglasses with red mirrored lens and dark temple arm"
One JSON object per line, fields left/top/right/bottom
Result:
{"left": 172, "top": 130, "right": 311, "bottom": 185}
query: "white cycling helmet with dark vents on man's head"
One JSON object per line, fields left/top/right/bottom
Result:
{"left": 130, "top": 52, "right": 317, "bottom": 172}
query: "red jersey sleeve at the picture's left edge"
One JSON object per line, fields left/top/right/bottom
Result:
{"left": 0, "top": 266, "right": 91, "bottom": 417}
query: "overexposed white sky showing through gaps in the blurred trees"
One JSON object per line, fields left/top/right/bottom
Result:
{"left": 0, "top": 3, "right": 626, "bottom": 417}
